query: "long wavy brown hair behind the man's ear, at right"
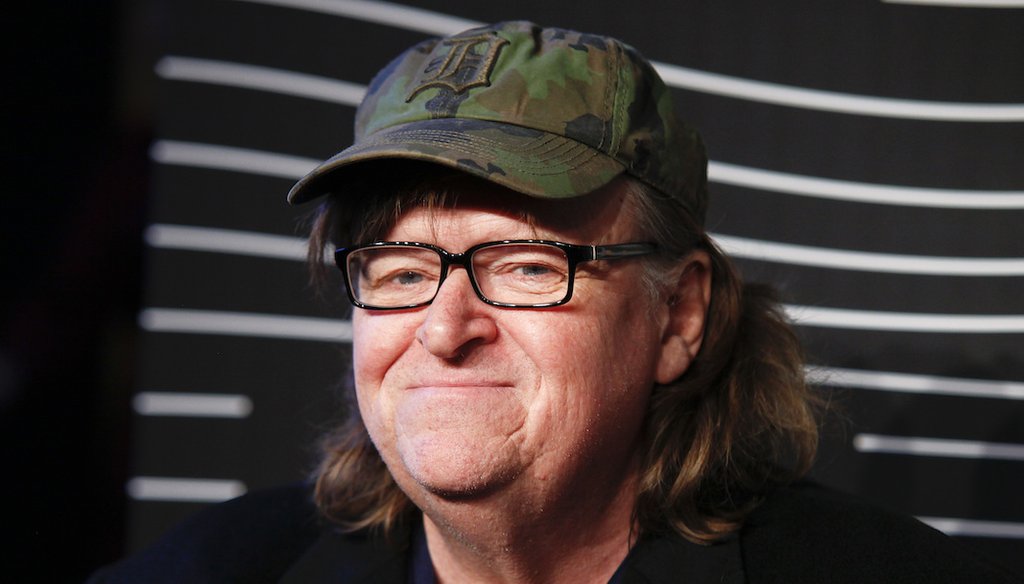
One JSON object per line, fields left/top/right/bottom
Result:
{"left": 630, "top": 181, "right": 822, "bottom": 542}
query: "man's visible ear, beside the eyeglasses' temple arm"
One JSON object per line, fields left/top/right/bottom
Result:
{"left": 655, "top": 250, "right": 712, "bottom": 383}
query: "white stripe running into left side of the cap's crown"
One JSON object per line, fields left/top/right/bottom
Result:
{"left": 156, "top": 56, "right": 367, "bottom": 107}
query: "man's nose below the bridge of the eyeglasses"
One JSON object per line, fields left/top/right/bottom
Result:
{"left": 416, "top": 268, "right": 498, "bottom": 359}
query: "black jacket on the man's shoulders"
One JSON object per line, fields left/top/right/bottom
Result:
{"left": 89, "top": 484, "right": 1019, "bottom": 584}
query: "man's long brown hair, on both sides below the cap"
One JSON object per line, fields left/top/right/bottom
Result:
{"left": 309, "top": 162, "right": 818, "bottom": 543}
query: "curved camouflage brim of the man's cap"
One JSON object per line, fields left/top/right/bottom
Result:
{"left": 288, "top": 118, "right": 625, "bottom": 204}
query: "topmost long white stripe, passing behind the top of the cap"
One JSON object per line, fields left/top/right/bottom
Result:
{"left": 228, "top": 0, "right": 1024, "bottom": 122}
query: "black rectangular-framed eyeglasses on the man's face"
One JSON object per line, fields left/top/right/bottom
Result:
{"left": 334, "top": 240, "right": 656, "bottom": 310}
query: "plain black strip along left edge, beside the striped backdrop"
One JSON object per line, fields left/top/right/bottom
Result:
{"left": 0, "top": 0, "right": 153, "bottom": 582}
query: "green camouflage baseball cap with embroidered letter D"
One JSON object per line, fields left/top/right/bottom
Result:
{"left": 288, "top": 22, "right": 708, "bottom": 222}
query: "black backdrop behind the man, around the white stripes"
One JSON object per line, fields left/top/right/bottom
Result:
{"left": 0, "top": 0, "right": 1024, "bottom": 582}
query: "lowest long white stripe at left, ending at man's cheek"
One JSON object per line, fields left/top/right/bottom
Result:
{"left": 138, "top": 308, "right": 352, "bottom": 342}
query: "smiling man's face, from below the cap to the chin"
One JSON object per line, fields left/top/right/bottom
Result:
{"left": 352, "top": 180, "right": 688, "bottom": 506}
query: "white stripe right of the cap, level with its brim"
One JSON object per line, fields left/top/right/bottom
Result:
{"left": 708, "top": 161, "right": 1024, "bottom": 209}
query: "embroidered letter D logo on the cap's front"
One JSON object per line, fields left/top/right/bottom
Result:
{"left": 406, "top": 33, "right": 509, "bottom": 102}
